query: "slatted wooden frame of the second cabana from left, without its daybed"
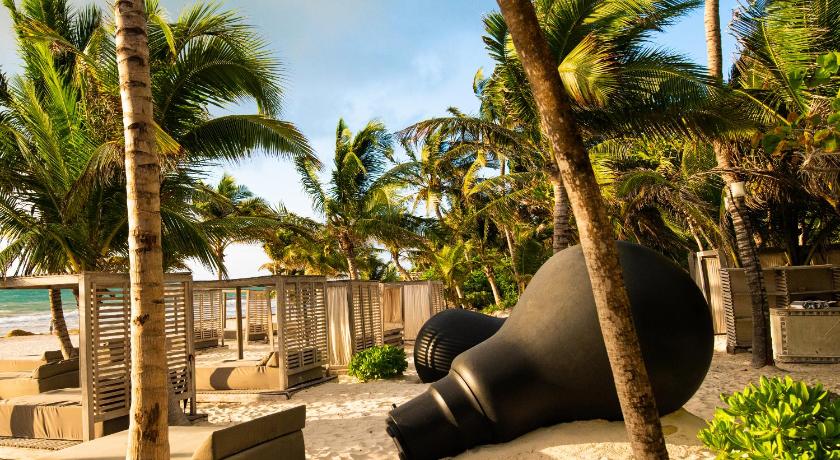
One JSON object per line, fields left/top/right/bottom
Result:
{"left": 193, "top": 276, "right": 328, "bottom": 389}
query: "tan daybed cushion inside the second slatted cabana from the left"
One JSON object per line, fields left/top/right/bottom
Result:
{"left": 195, "top": 360, "right": 281, "bottom": 391}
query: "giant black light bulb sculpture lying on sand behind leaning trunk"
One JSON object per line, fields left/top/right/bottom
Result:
{"left": 387, "top": 242, "right": 714, "bottom": 460}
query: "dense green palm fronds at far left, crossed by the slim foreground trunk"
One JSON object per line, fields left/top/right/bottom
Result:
{"left": 0, "top": 0, "right": 317, "bottom": 362}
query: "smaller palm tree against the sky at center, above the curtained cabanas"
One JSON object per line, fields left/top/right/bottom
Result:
{"left": 299, "top": 120, "right": 411, "bottom": 279}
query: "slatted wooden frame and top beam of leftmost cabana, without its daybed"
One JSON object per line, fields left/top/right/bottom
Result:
{"left": 0, "top": 272, "right": 195, "bottom": 440}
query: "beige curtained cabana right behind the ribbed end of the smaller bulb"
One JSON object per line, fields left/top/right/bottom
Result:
{"left": 382, "top": 281, "right": 449, "bottom": 343}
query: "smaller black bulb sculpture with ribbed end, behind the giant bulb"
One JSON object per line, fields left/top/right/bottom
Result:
{"left": 414, "top": 309, "right": 505, "bottom": 383}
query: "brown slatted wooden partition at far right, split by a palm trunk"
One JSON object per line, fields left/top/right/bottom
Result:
{"left": 720, "top": 265, "right": 840, "bottom": 353}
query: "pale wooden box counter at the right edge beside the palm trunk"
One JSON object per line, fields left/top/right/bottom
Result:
{"left": 770, "top": 308, "right": 840, "bottom": 363}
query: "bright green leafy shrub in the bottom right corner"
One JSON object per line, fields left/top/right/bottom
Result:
{"left": 698, "top": 377, "right": 840, "bottom": 460}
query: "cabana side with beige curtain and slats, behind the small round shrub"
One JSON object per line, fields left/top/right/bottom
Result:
{"left": 327, "top": 280, "right": 383, "bottom": 368}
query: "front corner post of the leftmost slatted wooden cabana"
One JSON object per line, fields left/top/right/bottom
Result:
{"left": 79, "top": 272, "right": 95, "bottom": 441}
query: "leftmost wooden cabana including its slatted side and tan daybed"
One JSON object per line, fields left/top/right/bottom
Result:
{"left": 0, "top": 272, "right": 195, "bottom": 440}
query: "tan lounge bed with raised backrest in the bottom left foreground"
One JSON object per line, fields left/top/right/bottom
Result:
{"left": 37, "top": 406, "right": 306, "bottom": 460}
